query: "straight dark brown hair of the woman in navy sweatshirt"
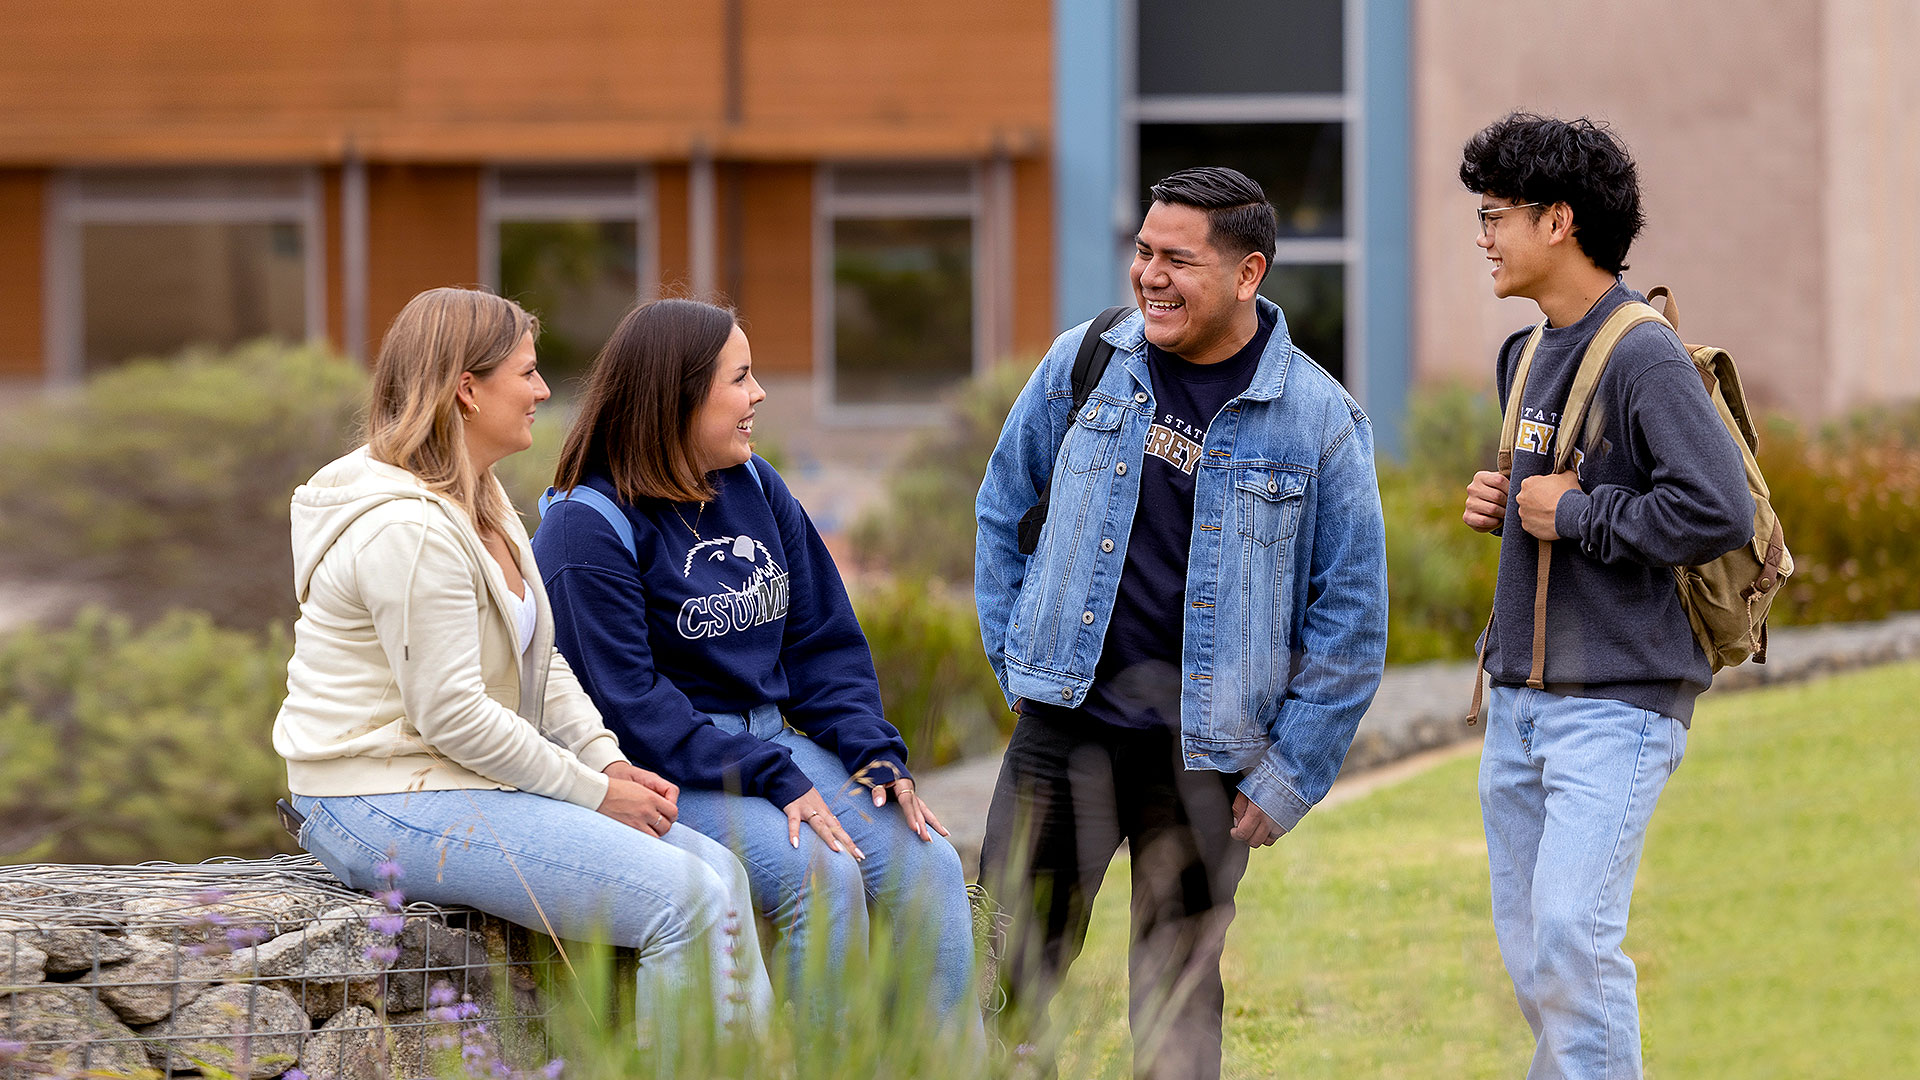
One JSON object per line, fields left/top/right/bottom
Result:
{"left": 553, "top": 300, "right": 735, "bottom": 503}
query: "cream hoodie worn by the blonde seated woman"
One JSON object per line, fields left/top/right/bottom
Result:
{"left": 273, "top": 446, "right": 624, "bottom": 809}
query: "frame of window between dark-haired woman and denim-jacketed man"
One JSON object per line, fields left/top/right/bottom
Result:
{"left": 812, "top": 160, "right": 1012, "bottom": 427}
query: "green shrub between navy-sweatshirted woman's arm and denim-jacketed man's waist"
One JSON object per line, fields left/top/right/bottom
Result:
{"left": 852, "top": 578, "right": 1014, "bottom": 769}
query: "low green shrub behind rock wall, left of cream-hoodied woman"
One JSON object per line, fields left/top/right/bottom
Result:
{"left": 0, "top": 609, "right": 294, "bottom": 863}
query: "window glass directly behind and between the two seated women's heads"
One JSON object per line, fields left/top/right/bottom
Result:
{"left": 482, "top": 167, "right": 657, "bottom": 392}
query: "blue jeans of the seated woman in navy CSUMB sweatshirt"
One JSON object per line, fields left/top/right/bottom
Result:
{"left": 680, "top": 705, "right": 983, "bottom": 1036}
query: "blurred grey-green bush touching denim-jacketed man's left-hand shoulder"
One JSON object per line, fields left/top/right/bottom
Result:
{"left": 849, "top": 363, "right": 1033, "bottom": 582}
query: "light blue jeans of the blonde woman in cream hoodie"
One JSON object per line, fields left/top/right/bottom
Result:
{"left": 292, "top": 790, "right": 774, "bottom": 1030}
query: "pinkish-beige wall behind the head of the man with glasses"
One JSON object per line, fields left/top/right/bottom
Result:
{"left": 1413, "top": 0, "right": 1827, "bottom": 413}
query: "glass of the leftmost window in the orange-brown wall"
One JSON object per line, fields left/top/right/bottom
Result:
{"left": 50, "top": 169, "right": 326, "bottom": 380}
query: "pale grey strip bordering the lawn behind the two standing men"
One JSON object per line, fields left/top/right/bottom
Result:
{"left": 920, "top": 613, "right": 1920, "bottom": 876}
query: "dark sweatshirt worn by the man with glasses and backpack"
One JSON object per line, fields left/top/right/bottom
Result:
{"left": 1486, "top": 282, "right": 1753, "bottom": 721}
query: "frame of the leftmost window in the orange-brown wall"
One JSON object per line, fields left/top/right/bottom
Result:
{"left": 42, "top": 165, "right": 328, "bottom": 386}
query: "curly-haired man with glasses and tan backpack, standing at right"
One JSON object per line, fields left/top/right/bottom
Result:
{"left": 1459, "top": 113, "right": 1791, "bottom": 1080}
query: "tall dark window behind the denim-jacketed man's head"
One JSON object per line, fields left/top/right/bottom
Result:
{"left": 1133, "top": 0, "right": 1359, "bottom": 379}
